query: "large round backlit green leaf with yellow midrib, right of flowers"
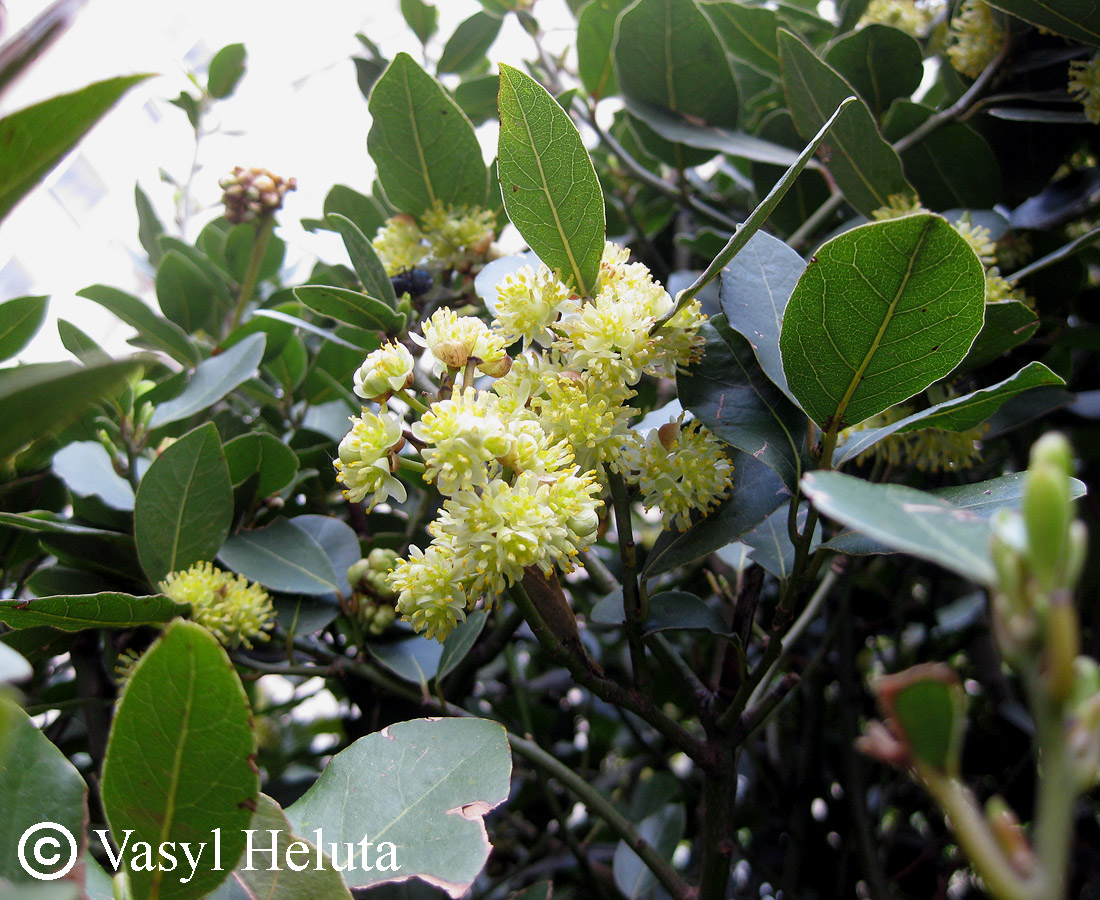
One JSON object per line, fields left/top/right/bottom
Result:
{"left": 780, "top": 215, "right": 986, "bottom": 431}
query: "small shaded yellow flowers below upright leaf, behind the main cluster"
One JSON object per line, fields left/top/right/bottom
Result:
{"left": 371, "top": 200, "right": 494, "bottom": 277}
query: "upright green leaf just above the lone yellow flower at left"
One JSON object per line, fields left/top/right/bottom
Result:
{"left": 134, "top": 421, "right": 233, "bottom": 584}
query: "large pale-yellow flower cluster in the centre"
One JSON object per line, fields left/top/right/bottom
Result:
{"left": 336, "top": 239, "right": 729, "bottom": 640}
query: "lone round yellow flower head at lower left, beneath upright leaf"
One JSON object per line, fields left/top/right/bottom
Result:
{"left": 160, "top": 562, "right": 275, "bottom": 649}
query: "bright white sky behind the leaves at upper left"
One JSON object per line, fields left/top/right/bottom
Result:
{"left": 0, "top": 0, "right": 569, "bottom": 361}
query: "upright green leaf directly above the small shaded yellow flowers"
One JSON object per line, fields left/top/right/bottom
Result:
{"left": 366, "top": 53, "right": 488, "bottom": 216}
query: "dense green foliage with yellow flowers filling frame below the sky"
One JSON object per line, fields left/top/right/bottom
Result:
{"left": 0, "top": 0, "right": 1100, "bottom": 900}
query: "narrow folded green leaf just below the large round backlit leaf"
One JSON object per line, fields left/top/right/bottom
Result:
{"left": 833, "top": 362, "right": 1066, "bottom": 467}
